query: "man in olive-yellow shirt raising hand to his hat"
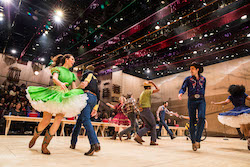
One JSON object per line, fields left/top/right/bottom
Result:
{"left": 134, "top": 81, "right": 160, "bottom": 145}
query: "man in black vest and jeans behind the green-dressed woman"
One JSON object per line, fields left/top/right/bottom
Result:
{"left": 70, "top": 65, "right": 101, "bottom": 156}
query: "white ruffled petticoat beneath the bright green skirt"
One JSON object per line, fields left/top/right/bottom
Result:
{"left": 26, "top": 93, "right": 88, "bottom": 118}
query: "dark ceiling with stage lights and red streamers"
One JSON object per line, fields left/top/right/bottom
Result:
{"left": 0, "top": 0, "right": 250, "bottom": 79}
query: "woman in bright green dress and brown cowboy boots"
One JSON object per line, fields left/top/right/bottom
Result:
{"left": 26, "top": 54, "right": 88, "bottom": 154}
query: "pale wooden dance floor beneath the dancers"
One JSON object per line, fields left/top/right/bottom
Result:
{"left": 0, "top": 136, "right": 250, "bottom": 167}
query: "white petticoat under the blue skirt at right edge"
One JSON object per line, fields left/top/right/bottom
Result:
{"left": 218, "top": 113, "right": 250, "bottom": 128}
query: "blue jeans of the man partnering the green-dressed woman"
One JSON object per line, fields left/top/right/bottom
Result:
{"left": 71, "top": 93, "right": 99, "bottom": 145}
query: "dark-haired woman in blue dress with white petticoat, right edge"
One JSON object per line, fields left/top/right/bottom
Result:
{"left": 211, "top": 85, "right": 250, "bottom": 150}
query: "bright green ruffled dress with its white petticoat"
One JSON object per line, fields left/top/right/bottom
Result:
{"left": 26, "top": 66, "right": 88, "bottom": 117}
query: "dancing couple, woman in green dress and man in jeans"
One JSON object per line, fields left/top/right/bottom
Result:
{"left": 26, "top": 54, "right": 100, "bottom": 155}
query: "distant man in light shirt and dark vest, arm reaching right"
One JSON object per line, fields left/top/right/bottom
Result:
{"left": 156, "top": 101, "right": 179, "bottom": 140}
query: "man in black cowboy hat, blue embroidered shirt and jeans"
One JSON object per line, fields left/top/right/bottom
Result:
{"left": 178, "top": 62, "right": 206, "bottom": 151}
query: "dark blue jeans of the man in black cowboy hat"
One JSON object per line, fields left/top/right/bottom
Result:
{"left": 188, "top": 99, "right": 206, "bottom": 143}
